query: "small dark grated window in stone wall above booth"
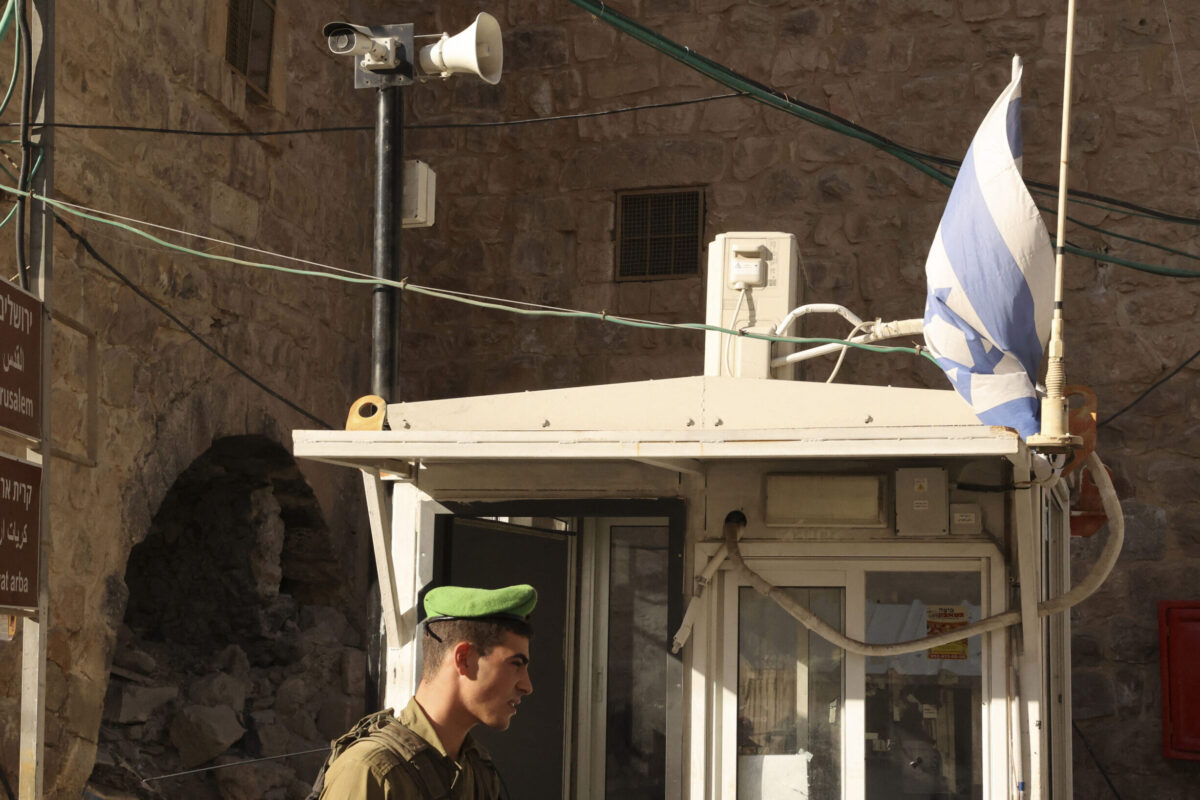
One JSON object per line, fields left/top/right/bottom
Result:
{"left": 617, "top": 188, "right": 704, "bottom": 281}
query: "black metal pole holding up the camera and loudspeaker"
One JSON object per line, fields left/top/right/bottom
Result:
{"left": 371, "top": 86, "right": 404, "bottom": 401}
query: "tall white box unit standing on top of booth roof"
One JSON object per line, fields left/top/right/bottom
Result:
{"left": 704, "top": 231, "right": 803, "bottom": 379}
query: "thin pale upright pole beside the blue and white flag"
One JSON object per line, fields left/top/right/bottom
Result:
{"left": 1028, "top": 0, "right": 1081, "bottom": 453}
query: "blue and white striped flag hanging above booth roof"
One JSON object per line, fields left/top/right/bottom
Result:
{"left": 925, "top": 56, "right": 1055, "bottom": 439}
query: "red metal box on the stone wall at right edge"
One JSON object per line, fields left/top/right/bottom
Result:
{"left": 1158, "top": 602, "right": 1200, "bottom": 760}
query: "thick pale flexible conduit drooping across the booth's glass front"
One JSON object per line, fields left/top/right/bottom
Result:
{"left": 673, "top": 452, "right": 1124, "bottom": 656}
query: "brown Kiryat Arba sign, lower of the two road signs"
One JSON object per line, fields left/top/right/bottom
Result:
{"left": 0, "top": 456, "right": 42, "bottom": 608}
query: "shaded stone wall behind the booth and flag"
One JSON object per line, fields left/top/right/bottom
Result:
{"left": 391, "top": 0, "right": 1200, "bottom": 798}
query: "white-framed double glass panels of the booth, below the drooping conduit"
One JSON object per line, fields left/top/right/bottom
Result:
{"left": 710, "top": 551, "right": 1008, "bottom": 800}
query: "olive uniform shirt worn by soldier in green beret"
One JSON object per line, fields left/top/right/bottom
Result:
{"left": 320, "top": 698, "right": 500, "bottom": 800}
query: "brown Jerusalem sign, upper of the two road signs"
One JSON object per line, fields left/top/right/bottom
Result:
{"left": 0, "top": 281, "right": 42, "bottom": 439}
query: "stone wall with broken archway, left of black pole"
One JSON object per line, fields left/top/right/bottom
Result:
{"left": 0, "top": 0, "right": 371, "bottom": 798}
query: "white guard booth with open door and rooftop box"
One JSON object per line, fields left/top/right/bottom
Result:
{"left": 294, "top": 234, "right": 1120, "bottom": 800}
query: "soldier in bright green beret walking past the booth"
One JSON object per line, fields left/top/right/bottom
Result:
{"left": 310, "top": 584, "right": 538, "bottom": 800}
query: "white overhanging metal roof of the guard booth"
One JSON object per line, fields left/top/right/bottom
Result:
{"left": 293, "top": 377, "right": 1021, "bottom": 474}
